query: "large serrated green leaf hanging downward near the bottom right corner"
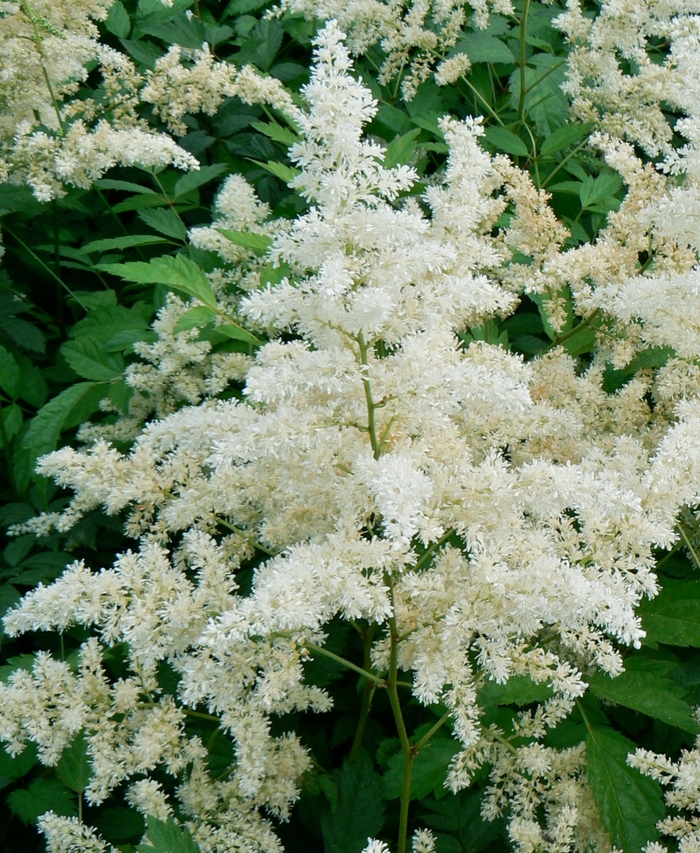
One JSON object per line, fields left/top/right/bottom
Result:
{"left": 586, "top": 724, "right": 665, "bottom": 853}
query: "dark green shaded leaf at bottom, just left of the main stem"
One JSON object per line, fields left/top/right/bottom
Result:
{"left": 321, "top": 750, "right": 384, "bottom": 853}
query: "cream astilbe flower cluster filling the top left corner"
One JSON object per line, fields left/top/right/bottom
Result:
{"left": 0, "top": 0, "right": 291, "bottom": 202}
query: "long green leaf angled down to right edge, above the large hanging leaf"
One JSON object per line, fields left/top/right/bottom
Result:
{"left": 590, "top": 670, "right": 700, "bottom": 734}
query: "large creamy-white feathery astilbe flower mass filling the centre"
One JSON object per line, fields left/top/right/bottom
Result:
{"left": 5, "top": 10, "right": 700, "bottom": 853}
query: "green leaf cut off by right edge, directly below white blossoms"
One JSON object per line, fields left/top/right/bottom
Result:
{"left": 639, "top": 579, "right": 700, "bottom": 648}
